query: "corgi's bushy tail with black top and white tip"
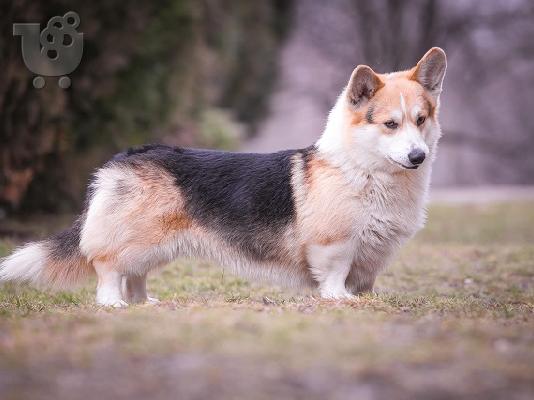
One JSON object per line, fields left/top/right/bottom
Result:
{"left": 0, "top": 218, "right": 94, "bottom": 289}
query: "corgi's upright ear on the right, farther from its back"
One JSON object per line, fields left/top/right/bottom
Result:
{"left": 411, "top": 47, "right": 447, "bottom": 97}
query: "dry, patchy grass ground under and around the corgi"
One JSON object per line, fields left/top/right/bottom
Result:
{"left": 0, "top": 202, "right": 534, "bottom": 400}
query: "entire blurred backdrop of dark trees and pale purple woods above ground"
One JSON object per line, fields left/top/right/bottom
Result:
{"left": 0, "top": 0, "right": 534, "bottom": 217}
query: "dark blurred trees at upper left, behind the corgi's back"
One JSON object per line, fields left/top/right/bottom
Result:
{"left": 0, "top": 0, "right": 291, "bottom": 211}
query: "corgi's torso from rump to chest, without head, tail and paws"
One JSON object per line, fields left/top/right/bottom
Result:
{"left": 80, "top": 146, "right": 430, "bottom": 292}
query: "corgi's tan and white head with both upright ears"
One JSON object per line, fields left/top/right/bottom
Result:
{"left": 322, "top": 47, "right": 447, "bottom": 172}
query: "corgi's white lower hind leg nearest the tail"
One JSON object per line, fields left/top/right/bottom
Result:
{"left": 93, "top": 260, "right": 128, "bottom": 308}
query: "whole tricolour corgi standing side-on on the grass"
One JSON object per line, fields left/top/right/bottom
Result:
{"left": 0, "top": 47, "right": 447, "bottom": 307}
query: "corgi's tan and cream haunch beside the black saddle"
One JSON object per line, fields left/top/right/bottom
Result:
{"left": 81, "top": 164, "right": 188, "bottom": 268}
